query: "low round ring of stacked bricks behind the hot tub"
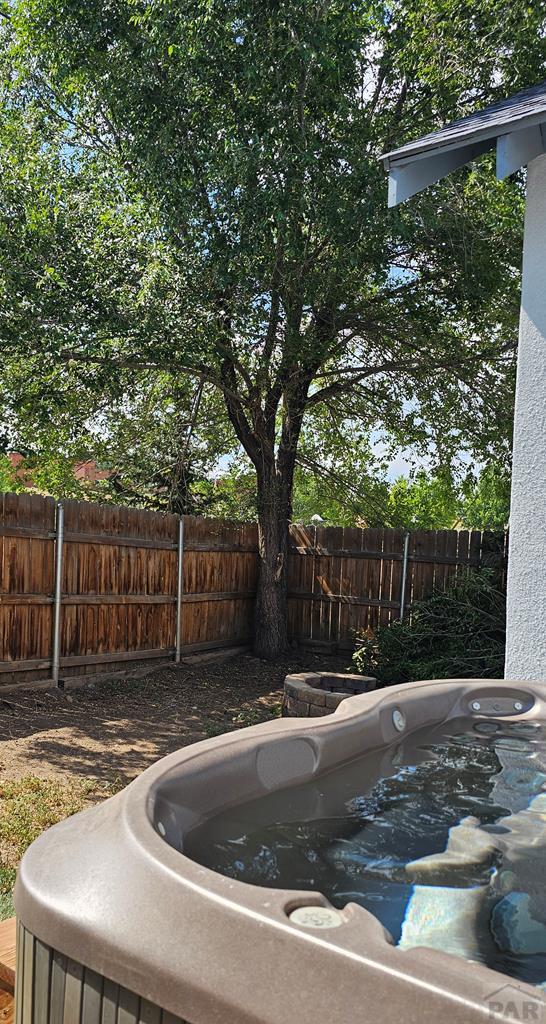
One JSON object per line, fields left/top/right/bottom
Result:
{"left": 283, "top": 672, "right": 377, "bottom": 718}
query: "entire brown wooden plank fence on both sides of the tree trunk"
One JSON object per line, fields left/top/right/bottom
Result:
{"left": 0, "top": 494, "right": 504, "bottom": 686}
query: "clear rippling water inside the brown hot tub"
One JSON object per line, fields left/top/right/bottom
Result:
{"left": 184, "top": 719, "right": 546, "bottom": 984}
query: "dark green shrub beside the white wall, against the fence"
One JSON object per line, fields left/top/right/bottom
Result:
{"left": 353, "top": 569, "right": 506, "bottom": 686}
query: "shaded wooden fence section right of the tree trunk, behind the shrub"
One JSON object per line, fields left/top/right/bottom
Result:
{"left": 288, "top": 525, "right": 507, "bottom": 649}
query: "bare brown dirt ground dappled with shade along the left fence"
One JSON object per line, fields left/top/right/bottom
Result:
{"left": 0, "top": 651, "right": 350, "bottom": 783}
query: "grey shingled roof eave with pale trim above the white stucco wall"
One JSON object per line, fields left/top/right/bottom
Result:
{"left": 380, "top": 82, "right": 546, "bottom": 206}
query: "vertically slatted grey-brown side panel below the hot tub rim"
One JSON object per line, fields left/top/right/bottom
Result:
{"left": 15, "top": 922, "right": 190, "bottom": 1024}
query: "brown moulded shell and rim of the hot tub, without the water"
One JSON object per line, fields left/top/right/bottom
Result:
{"left": 15, "top": 680, "right": 546, "bottom": 1024}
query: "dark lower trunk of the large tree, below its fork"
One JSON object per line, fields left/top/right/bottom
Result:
{"left": 254, "top": 467, "right": 291, "bottom": 660}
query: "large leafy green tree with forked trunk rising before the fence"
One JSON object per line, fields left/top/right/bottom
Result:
{"left": 4, "top": 0, "right": 544, "bottom": 656}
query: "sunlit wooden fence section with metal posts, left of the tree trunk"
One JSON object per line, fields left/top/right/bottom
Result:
{"left": 0, "top": 494, "right": 257, "bottom": 686}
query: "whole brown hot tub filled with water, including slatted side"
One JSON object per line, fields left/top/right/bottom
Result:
{"left": 15, "top": 680, "right": 546, "bottom": 1024}
